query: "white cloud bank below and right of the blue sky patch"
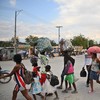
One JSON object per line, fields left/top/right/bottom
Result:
{"left": 0, "top": 0, "right": 100, "bottom": 42}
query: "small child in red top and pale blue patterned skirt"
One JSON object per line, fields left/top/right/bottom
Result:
{"left": 30, "top": 62, "right": 45, "bottom": 100}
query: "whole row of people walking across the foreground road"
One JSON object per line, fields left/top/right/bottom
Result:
{"left": 0, "top": 40, "right": 100, "bottom": 100}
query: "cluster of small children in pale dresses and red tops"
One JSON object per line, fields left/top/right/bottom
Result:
{"left": 29, "top": 62, "right": 59, "bottom": 100}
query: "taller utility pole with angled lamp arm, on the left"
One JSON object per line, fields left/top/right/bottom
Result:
{"left": 14, "top": 10, "right": 22, "bottom": 54}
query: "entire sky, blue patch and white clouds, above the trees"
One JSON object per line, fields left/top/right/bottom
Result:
{"left": 0, "top": 0, "right": 100, "bottom": 42}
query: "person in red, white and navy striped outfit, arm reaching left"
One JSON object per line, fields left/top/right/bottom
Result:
{"left": 0, "top": 54, "right": 32, "bottom": 100}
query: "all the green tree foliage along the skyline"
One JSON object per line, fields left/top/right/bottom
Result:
{"left": 0, "top": 34, "right": 97, "bottom": 49}
